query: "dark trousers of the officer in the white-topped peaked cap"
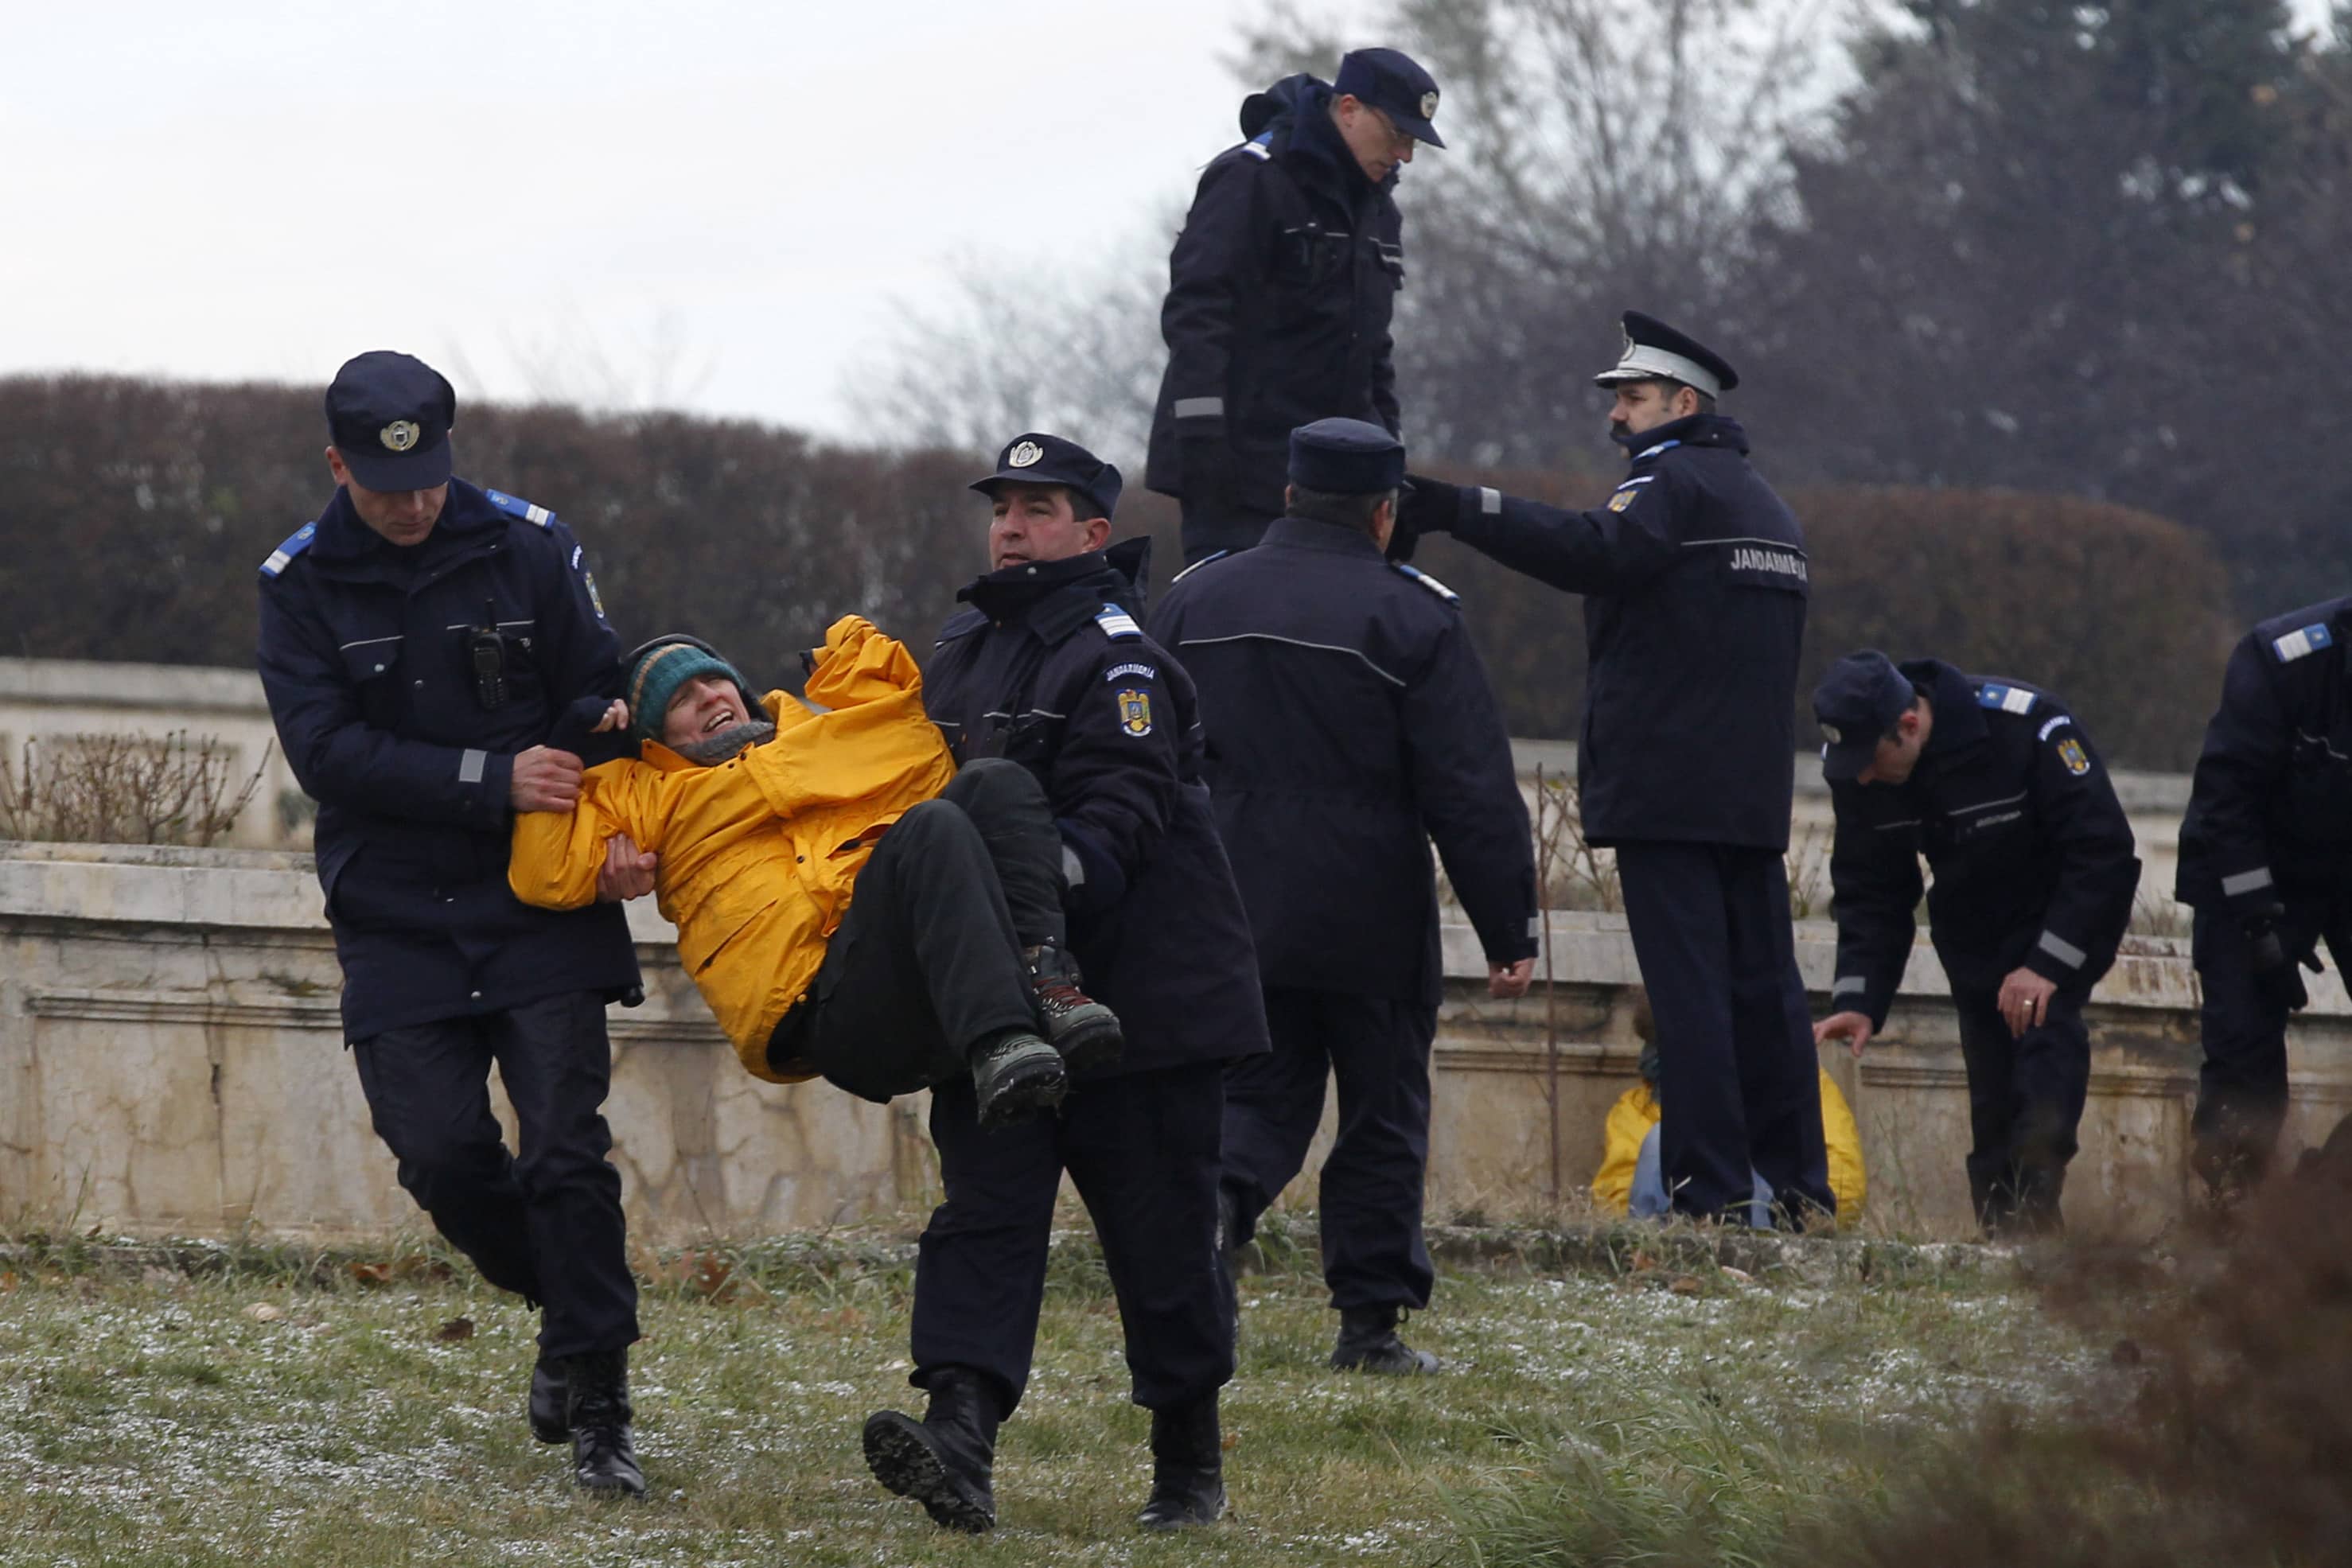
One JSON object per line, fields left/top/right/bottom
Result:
{"left": 1616, "top": 842, "right": 1837, "bottom": 1223}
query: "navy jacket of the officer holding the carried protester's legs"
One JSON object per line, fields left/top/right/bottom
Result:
{"left": 922, "top": 541, "right": 1268, "bottom": 1072}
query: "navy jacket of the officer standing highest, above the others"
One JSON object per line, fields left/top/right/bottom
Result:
{"left": 1143, "top": 76, "right": 1404, "bottom": 515}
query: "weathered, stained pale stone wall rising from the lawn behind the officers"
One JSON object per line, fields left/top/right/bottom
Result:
{"left": 0, "top": 844, "right": 2352, "bottom": 1243}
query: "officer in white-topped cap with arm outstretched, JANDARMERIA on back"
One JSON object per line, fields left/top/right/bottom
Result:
{"left": 1400, "top": 310, "right": 1835, "bottom": 1223}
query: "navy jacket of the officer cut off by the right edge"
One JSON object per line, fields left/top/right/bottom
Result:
{"left": 2173, "top": 600, "right": 2352, "bottom": 915}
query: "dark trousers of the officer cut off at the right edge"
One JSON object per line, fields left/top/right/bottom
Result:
{"left": 2190, "top": 893, "right": 2352, "bottom": 1182}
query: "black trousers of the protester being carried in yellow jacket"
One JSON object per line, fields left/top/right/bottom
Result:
{"left": 767, "top": 757, "right": 1063, "bottom": 1100}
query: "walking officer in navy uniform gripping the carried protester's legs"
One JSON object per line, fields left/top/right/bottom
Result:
{"left": 866, "top": 433, "right": 1265, "bottom": 1531}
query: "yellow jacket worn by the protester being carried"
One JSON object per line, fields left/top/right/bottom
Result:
{"left": 506, "top": 616, "right": 955, "bottom": 1084}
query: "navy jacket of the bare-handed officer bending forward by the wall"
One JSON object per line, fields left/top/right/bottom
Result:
{"left": 1830, "top": 658, "right": 2140, "bottom": 1027}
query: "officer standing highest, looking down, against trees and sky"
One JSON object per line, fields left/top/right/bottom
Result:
{"left": 1146, "top": 49, "right": 1444, "bottom": 564}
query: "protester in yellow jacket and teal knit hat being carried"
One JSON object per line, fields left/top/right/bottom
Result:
{"left": 508, "top": 616, "right": 1096, "bottom": 1126}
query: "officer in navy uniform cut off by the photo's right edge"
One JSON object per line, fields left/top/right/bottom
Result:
{"left": 2173, "top": 600, "right": 2352, "bottom": 1194}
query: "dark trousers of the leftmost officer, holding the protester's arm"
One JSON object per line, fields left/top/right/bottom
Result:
{"left": 350, "top": 992, "right": 637, "bottom": 1356}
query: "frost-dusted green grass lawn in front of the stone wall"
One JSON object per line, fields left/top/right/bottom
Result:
{"left": 0, "top": 1231, "right": 2105, "bottom": 1568}
